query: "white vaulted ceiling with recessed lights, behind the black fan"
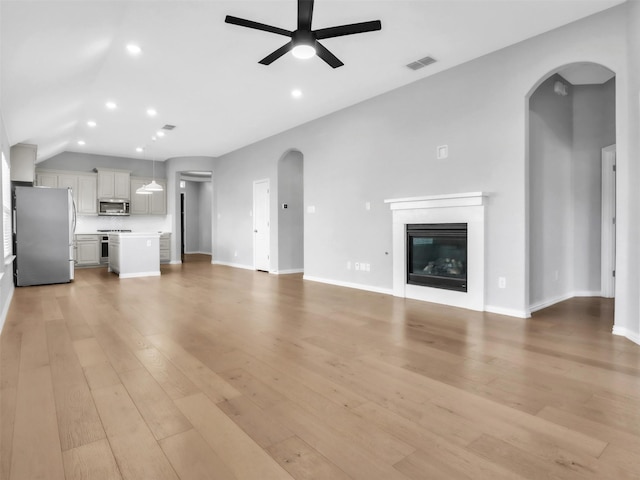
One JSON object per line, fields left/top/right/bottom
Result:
{"left": 0, "top": 0, "right": 623, "bottom": 161}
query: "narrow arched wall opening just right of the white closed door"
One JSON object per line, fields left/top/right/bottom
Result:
{"left": 278, "top": 149, "right": 304, "bottom": 274}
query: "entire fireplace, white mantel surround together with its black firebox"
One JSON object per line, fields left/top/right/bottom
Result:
{"left": 385, "top": 192, "right": 486, "bottom": 311}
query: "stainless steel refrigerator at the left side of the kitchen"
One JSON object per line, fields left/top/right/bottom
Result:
{"left": 14, "top": 186, "right": 76, "bottom": 287}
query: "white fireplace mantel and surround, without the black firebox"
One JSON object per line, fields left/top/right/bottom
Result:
{"left": 385, "top": 192, "right": 487, "bottom": 311}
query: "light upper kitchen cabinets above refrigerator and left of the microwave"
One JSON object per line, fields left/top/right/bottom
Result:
{"left": 36, "top": 170, "right": 98, "bottom": 215}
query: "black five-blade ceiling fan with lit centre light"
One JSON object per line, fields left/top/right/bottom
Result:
{"left": 224, "top": 0, "right": 382, "bottom": 68}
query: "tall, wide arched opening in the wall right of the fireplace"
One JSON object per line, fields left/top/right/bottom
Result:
{"left": 527, "top": 63, "right": 616, "bottom": 312}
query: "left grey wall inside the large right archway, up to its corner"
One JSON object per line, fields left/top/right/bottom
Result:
{"left": 529, "top": 75, "right": 574, "bottom": 309}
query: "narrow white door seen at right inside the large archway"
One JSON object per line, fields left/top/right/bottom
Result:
{"left": 600, "top": 145, "right": 616, "bottom": 298}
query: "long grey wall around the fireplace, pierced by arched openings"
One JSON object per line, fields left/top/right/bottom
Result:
{"left": 211, "top": 5, "right": 637, "bottom": 316}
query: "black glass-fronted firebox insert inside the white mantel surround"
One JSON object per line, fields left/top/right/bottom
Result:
{"left": 406, "top": 223, "right": 467, "bottom": 292}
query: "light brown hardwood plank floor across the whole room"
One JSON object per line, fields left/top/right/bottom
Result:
{"left": 0, "top": 262, "right": 640, "bottom": 480}
